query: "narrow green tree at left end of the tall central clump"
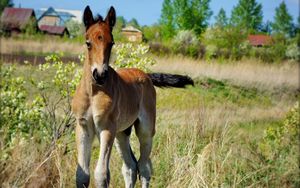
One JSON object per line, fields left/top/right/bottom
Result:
{"left": 159, "top": 0, "right": 175, "bottom": 39}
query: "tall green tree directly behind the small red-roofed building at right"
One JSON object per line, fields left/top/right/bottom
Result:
{"left": 230, "top": 0, "right": 263, "bottom": 31}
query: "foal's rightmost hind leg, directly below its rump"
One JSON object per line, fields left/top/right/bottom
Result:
{"left": 135, "top": 119, "right": 154, "bottom": 188}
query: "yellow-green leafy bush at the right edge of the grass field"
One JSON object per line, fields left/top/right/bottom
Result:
{"left": 258, "top": 102, "right": 300, "bottom": 184}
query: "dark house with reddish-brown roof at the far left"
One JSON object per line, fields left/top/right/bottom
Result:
{"left": 0, "top": 7, "right": 38, "bottom": 35}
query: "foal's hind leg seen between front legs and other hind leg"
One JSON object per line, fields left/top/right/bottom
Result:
{"left": 116, "top": 127, "right": 137, "bottom": 188}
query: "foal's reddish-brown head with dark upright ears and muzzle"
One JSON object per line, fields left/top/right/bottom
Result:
{"left": 83, "top": 6, "right": 116, "bottom": 85}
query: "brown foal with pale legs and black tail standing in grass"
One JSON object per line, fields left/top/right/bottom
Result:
{"left": 72, "top": 6, "right": 193, "bottom": 187}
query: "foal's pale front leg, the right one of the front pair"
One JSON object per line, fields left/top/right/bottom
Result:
{"left": 95, "top": 125, "right": 116, "bottom": 188}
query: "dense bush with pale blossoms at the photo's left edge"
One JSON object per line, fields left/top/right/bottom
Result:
{"left": 0, "top": 66, "right": 45, "bottom": 144}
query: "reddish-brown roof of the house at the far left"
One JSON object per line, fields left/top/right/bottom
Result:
{"left": 1, "top": 7, "right": 35, "bottom": 29}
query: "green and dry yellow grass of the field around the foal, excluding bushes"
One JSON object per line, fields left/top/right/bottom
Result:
{"left": 0, "top": 58, "right": 299, "bottom": 187}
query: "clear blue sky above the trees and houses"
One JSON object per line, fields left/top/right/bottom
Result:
{"left": 13, "top": 0, "right": 300, "bottom": 25}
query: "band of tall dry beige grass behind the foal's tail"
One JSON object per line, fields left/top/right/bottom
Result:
{"left": 152, "top": 57, "right": 300, "bottom": 90}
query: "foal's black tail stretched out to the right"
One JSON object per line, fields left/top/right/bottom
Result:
{"left": 148, "top": 73, "right": 194, "bottom": 88}
